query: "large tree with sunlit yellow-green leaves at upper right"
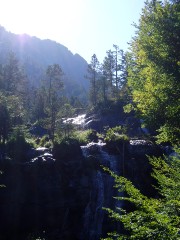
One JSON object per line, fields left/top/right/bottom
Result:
{"left": 128, "top": 1, "right": 180, "bottom": 143}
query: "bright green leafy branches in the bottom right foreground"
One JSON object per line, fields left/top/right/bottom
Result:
{"left": 104, "top": 150, "right": 180, "bottom": 240}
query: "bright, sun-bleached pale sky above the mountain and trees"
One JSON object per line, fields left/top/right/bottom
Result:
{"left": 0, "top": 0, "right": 144, "bottom": 62}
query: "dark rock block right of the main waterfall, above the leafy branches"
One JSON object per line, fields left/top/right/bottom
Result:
{"left": 124, "top": 139, "right": 162, "bottom": 197}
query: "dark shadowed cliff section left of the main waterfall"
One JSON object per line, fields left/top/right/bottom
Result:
{"left": 0, "top": 149, "right": 91, "bottom": 240}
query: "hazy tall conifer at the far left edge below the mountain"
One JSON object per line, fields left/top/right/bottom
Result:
{"left": 0, "top": 52, "right": 27, "bottom": 139}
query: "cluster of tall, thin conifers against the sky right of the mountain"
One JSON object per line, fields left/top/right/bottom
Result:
{"left": 87, "top": 45, "right": 127, "bottom": 107}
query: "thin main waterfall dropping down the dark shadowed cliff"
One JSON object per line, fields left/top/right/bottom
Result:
{"left": 82, "top": 142, "right": 122, "bottom": 240}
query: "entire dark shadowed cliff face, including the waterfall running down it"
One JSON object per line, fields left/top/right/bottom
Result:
{"left": 0, "top": 140, "right": 163, "bottom": 240}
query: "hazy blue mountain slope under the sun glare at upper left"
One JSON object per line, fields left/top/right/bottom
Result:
{"left": 0, "top": 26, "right": 89, "bottom": 98}
